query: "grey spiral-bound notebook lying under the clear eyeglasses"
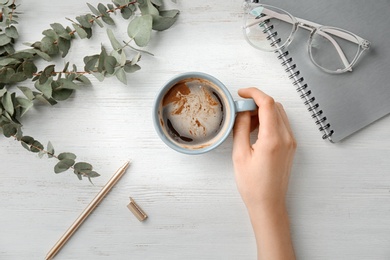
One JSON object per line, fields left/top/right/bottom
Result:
{"left": 261, "top": 0, "right": 390, "bottom": 142}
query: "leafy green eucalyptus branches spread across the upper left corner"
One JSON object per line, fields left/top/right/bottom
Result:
{"left": 0, "top": 0, "right": 179, "bottom": 179}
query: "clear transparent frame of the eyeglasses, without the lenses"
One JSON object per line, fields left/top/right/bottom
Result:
{"left": 243, "top": 0, "right": 371, "bottom": 74}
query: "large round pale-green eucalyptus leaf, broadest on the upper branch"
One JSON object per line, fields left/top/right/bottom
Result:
{"left": 127, "top": 15, "right": 153, "bottom": 47}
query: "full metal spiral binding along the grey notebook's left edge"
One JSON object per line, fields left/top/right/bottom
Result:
{"left": 259, "top": 14, "right": 334, "bottom": 140}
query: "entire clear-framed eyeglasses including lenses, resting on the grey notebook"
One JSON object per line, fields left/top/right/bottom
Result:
{"left": 243, "top": 0, "right": 370, "bottom": 73}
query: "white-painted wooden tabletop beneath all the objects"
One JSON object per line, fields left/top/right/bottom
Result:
{"left": 0, "top": 0, "right": 390, "bottom": 260}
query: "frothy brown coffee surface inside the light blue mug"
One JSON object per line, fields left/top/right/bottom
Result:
{"left": 162, "top": 78, "right": 226, "bottom": 147}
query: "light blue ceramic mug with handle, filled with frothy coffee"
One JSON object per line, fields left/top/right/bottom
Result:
{"left": 153, "top": 72, "right": 257, "bottom": 154}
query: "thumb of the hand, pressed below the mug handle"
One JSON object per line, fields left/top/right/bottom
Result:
{"left": 233, "top": 111, "right": 251, "bottom": 158}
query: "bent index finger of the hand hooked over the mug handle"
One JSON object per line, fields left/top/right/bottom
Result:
{"left": 238, "top": 88, "right": 279, "bottom": 134}
